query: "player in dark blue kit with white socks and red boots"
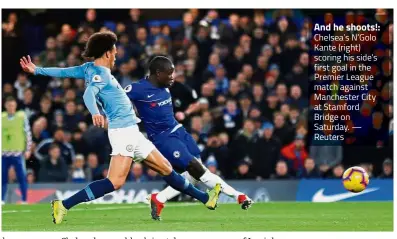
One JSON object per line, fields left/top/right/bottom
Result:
{"left": 125, "top": 56, "right": 253, "bottom": 220}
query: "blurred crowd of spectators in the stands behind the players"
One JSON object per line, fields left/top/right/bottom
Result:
{"left": 2, "top": 9, "right": 393, "bottom": 183}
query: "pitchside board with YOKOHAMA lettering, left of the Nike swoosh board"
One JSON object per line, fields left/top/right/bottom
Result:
{"left": 6, "top": 181, "right": 298, "bottom": 204}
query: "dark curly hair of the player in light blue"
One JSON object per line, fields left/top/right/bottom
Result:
{"left": 83, "top": 31, "right": 117, "bottom": 59}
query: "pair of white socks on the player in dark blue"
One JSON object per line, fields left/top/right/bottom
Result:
{"left": 157, "top": 170, "right": 243, "bottom": 203}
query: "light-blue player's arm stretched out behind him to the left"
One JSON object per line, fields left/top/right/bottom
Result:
{"left": 19, "top": 55, "right": 84, "bottom": 78}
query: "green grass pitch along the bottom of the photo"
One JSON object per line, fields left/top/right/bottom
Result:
{"left": 2, "top": 202, "right": 393, "bottom": 231}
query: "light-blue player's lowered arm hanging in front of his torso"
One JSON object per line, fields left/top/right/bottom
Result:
{"left": 83, "top": 85, "right": 105, "bottom": 128}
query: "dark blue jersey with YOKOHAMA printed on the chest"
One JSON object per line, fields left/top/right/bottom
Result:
{"left": 125, "top": 78, "right": 179, "bottom": 140}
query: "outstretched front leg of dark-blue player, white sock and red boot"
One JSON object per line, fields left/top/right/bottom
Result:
{"left": 187, "top": 159, "right": 253, "bottom": 210}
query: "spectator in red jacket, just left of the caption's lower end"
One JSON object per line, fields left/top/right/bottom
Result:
{"left": 281, "top": 135, "right": 309, "bottom": 172}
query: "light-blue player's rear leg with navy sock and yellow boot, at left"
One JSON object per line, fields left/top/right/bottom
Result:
{"left": 51, "top": 155, "right": 132, "bottom": 224}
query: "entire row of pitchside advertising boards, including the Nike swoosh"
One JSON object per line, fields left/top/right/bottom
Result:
{"left": 6, "top": 180, "right": 393, "bottom": 204}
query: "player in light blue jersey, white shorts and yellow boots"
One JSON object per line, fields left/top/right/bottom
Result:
{"left": 20, "top": 32, "right": 221, "bottom": 224}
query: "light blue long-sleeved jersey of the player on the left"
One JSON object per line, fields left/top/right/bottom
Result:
{"left": 35, "top": 62, "right": 139, "bottom": 128}
